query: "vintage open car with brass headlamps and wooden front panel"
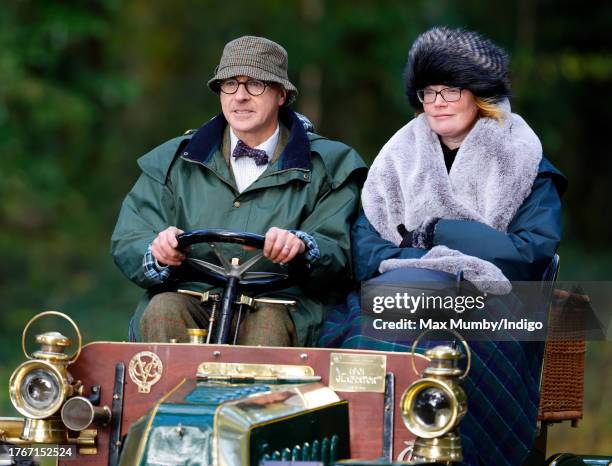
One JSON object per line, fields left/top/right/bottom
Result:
{"left": 0, "top": 230, "right": 612, "bottom": 466}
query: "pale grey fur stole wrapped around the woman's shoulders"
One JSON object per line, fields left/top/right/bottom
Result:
{"left": 361, "top": 101, "right": 542, "bottom": 294}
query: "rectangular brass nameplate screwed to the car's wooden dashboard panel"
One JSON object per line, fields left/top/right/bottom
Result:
{"left": 329, "top": 353, "right": 387, "bottom": 393}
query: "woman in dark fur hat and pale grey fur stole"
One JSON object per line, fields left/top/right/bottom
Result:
{"left": 322, "top": 27, "right": 566, "bottom": 466}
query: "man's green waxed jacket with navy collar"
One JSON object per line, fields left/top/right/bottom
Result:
{"left": 111, "top": 109, "right": 367, "bottom": 345}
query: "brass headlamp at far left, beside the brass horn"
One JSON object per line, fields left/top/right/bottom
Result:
{"left": 9, "top": 311, "right": 82, "bottom": 443}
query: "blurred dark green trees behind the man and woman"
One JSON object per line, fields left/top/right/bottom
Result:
{"left": 0, "top": 0, "right": 612, "bottom": 454}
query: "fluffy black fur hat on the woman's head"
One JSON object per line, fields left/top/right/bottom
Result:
{"left": 404, "top": 27, "right": 510, "bottom": 109}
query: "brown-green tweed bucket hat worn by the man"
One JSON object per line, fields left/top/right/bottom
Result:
{"left": 208, "top": 36, "right": 298, "bottom": 105}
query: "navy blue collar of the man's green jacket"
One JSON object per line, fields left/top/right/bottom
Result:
{"left": 181, "top": 107, "right": 311, "bottom": 170}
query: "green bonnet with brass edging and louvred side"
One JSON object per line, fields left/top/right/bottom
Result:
{"left": 120, "top": 379, "right": 349, "bottom": 466}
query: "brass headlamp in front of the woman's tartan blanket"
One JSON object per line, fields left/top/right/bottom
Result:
{"left": 400, "top": 335, "right": 471, "bottom": 462}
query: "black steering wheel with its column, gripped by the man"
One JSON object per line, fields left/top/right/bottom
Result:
{"left": 176, "top": 229, "right": 291, "bottom": 344}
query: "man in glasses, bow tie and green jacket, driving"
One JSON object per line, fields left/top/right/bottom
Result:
{"left": 111, "top": 36, "right": 366, "bottom": 346}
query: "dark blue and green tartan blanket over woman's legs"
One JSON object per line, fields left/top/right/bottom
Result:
{"left": 319, "top": 292, "right": 544, "bottom": 466}
